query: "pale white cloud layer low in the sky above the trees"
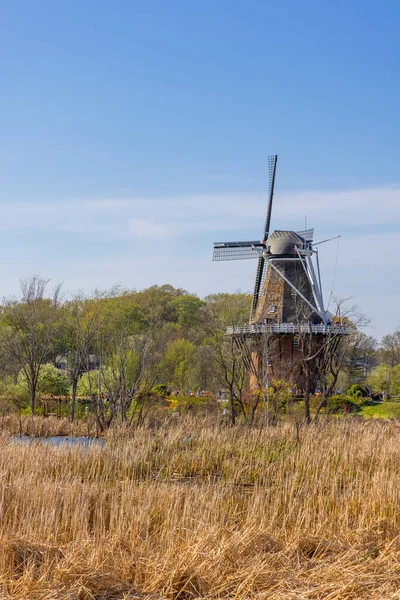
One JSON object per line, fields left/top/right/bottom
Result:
{"left": 0, "top": 187, "right": 400, "bottom": 336}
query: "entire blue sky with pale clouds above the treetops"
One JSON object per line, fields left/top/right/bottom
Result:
{"left": 0, "top": 0, "right": 400, "bottom": 337}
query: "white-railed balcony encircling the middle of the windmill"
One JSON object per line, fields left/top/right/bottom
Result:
{"left": 226, "top": 323, "right": 352, "bottom": 336}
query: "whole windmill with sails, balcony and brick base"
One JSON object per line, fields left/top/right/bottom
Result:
{"left": 213, "top": 155, "right": 341, "bottom": 389}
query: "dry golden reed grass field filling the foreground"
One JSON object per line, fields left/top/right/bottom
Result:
{"left": 0, "top": 418, "right": 400, "bottom": 600}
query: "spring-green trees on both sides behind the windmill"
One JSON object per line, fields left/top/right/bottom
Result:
{"left": 0, "top": 276, "right": 400, "bottom": 428}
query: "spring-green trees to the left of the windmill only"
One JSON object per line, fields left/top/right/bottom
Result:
{"left": 0, "top": 276, "right": 250, "bottom": 427}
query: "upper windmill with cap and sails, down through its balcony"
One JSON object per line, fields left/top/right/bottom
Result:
{"left": 213, "top": 155, "right": 342, "bottom": 390}
